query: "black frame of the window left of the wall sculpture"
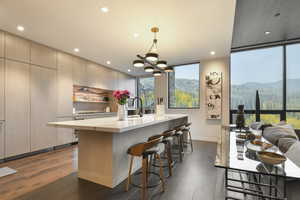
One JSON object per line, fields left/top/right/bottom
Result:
{"left": 167, "top": 61, "right": 201, "bottom": 110}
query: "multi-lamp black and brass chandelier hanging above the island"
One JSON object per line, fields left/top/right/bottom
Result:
{"left": 133, "top": 27, "right": 173, "bottom": 76}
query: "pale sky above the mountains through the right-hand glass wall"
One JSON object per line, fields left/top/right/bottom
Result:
{"left": 231, "top": 44, "right": 300, "bottom": 85}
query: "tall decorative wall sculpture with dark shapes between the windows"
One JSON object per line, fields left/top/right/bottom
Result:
{"left": 205, "top": 72, "right": 222, "bottom": 119}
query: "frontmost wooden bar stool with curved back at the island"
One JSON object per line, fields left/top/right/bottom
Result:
{"left": 126, "top": 136, "right": 165, "bottom": 200}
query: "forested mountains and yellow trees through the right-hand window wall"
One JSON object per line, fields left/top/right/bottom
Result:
{"left": 231, "top": 79, "right": 300, "bottom": 128}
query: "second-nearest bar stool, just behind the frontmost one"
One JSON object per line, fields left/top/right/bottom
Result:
{"left": 148, "top": 129, "right": 175, "bottom": 176}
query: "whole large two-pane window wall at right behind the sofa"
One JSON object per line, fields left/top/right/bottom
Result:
{"left": 230, "top": 44, "right": 300, "bottom": 129}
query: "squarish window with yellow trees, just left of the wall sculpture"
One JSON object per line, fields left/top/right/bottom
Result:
{"left": 168, "top": 63, "right": 200, "bottom": 109}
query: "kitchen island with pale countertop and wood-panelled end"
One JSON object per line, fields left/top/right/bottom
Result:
{"left": 48, "top": 114, "right": 188, "bottom": 188}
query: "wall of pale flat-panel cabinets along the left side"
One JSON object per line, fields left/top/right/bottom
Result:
{"left": 0, "top": 30, "right": 135, "bottom": 159}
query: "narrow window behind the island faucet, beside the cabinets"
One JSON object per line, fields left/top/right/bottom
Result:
{"left": 138, "top": 77, "right": 155, "bottom": 110}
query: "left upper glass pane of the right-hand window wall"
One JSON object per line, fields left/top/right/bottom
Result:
{"left": 231, "top": 47, "right": 283, "bottom": 110}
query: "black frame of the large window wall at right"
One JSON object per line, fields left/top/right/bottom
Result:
{"left": 229, "top": 40, "right": 300, "bottom": 124}
